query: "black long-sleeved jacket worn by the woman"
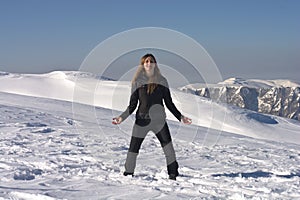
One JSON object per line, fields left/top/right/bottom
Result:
{"left": 120, "top": 75, "right": 181, "bottom": 121}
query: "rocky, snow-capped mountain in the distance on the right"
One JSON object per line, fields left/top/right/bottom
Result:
{"left": 181, "top": 78, "right": 300, "bottom": 120}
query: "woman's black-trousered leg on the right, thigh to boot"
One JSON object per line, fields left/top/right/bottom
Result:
{"left": 156, "top": 123, "right": 179, "bottom": 177}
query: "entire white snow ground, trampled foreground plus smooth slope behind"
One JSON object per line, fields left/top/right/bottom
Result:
{"left": 0, "top": 72, "right": 300, "bottom": 200}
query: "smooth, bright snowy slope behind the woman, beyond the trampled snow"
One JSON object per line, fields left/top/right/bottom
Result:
{"left": 0, "top": 71, "right": 300, "bottom": 144}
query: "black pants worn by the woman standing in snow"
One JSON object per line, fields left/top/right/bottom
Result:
{"left": 125, "top": 120, "right": 178, "bottom": 176}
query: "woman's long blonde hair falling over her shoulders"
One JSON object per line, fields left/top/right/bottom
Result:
{"left": 131, "top": 53, "right": 161, "bottom": 94}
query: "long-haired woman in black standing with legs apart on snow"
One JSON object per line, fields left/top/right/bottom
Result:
{"left": 113, "top": 54, "right": 192, "bottom": 180}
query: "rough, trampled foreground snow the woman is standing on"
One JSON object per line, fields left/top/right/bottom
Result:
{"left": 0, "top": 93, "right": 300, "bottom": 200}
